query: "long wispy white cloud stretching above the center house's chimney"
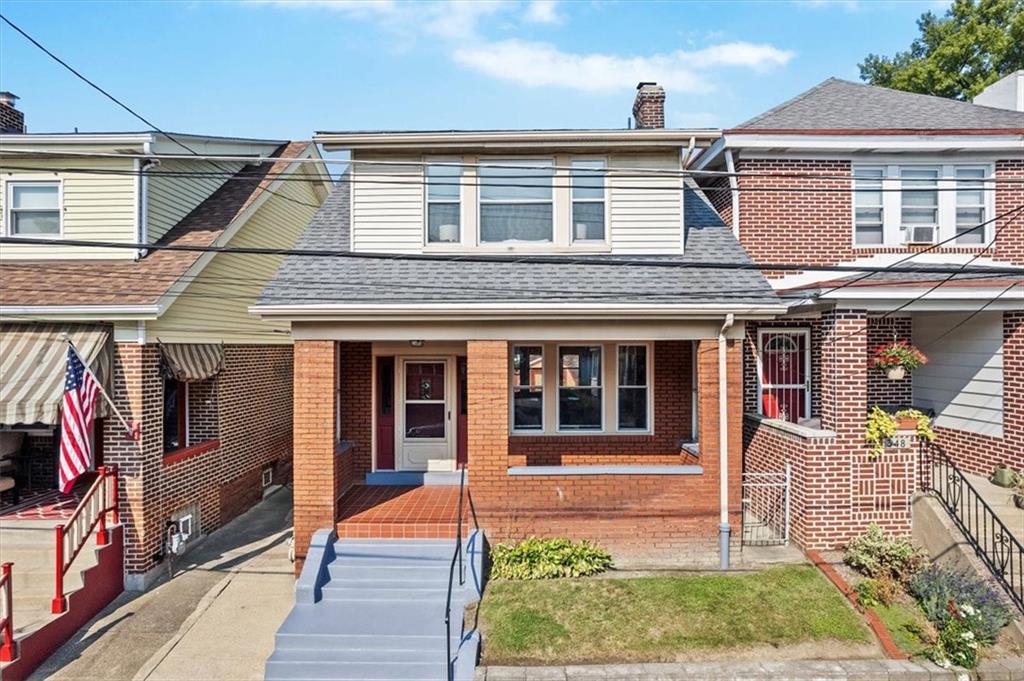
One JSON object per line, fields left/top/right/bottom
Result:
{"left": 453, "top": 40, "right": 794, "bottom": 92}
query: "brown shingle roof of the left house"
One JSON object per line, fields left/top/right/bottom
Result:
{"left": 0, "top": 141, "right": 311, "bottom": 306}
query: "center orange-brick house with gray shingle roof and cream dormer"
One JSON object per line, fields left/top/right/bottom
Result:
{"left": 253, "top": 83, "right": 781, "bottom": 566}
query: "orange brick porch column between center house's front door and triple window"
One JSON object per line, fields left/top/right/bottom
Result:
{"left": 466, "top": 340, "right": 509, "bottom": 520}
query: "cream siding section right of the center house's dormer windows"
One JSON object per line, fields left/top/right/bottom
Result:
{"left": 608, "top": 154, "right": 683, "bottom": 254}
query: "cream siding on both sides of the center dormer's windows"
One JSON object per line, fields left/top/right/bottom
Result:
{"left": 351, "top": 153, "right": 683, "bottom": 254}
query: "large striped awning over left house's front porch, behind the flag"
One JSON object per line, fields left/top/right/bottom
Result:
{"left": 0, "top": 324, "right": 111, "bottom": 426}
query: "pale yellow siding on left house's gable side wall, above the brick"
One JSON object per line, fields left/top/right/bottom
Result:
{"left": 145, "top": 164, "right": 321, "bottom": 343}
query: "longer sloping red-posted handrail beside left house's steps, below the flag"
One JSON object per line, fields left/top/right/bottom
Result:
{"left": 50, "top": 466, "right": 119, "bottom": 614}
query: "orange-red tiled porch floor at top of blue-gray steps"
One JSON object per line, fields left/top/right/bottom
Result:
{"left": 338, "top": 484, "right": 466, "bottom": 539}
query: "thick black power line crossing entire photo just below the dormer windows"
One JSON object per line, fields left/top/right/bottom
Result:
{"left": 0, "top": 233, "right": 1024, "bottom": 276}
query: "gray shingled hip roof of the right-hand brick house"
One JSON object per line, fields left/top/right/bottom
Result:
{"left": 726, "top": 78, "right": 1024, "bottom": 134}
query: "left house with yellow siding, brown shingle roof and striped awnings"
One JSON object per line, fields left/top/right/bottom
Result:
{"left": 0, "top": 93, "right": 330, "bottom": 588}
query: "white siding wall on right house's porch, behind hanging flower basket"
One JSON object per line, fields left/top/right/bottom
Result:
{"left": 912, "top": 312, "right": 1004, "bottom": 437}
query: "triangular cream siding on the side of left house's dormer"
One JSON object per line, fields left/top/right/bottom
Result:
{"left": 146, "top": 159, "right": 243, "bottom": 243}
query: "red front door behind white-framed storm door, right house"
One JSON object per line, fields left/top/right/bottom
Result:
{"left": 759, "top": 330, "right": 810, "bottom": 423}
